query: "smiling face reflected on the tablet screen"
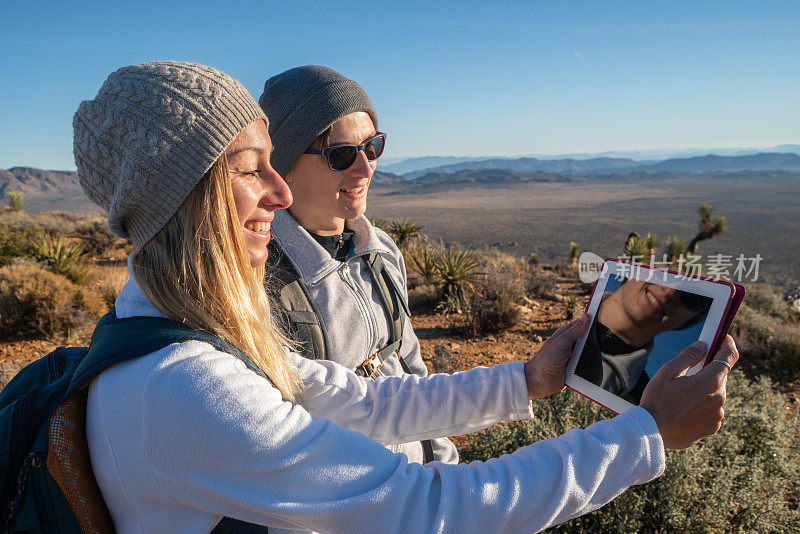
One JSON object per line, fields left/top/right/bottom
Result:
{"left": 618, "top": 280, "right": 697, "bottom": 335}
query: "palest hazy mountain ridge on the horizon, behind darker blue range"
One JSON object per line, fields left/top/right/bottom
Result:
{"left": 381, "top": 144, "right": 800, "bottom": 174}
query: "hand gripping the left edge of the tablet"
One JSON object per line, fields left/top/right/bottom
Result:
{"left": 525, "top": 313, "right": 591, "bottom": 400}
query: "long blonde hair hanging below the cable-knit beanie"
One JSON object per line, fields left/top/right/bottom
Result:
{"left": 131, "top": 154, "right": 301, "bottom": 401}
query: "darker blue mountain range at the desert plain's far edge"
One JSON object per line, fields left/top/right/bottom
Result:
{"left": 406, "top": 153, "right": 800, "bottom": 179}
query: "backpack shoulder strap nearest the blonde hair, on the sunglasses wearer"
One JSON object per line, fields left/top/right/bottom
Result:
{"left": 264, "top": 240, "right": 330, "bottom": 360}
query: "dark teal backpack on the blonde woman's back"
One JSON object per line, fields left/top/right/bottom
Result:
{"left": 0, "top": 311, "right": 267, "bottom": 534}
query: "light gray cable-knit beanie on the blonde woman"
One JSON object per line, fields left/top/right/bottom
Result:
{"left": 72, "top": 61, "right": 264, "bottom": 250}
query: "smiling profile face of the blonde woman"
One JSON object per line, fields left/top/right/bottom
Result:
{"left": 225, "top": 119, "right": 292, "bottom": 267}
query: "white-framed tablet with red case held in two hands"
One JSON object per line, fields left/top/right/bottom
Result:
{"left": 565, "top": 258, "right": 744, "bottom": 414}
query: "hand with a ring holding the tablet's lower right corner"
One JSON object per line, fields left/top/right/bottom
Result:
{"left": 640, "top": 336, "right": 739, "bottom": 449}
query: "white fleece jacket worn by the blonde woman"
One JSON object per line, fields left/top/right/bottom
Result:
{"left": 87, "top": 272, "right": 664, "bottom": 534}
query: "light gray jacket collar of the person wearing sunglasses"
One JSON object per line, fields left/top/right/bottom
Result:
{"left": 272, "top": 210, "right": 391, "bottom": 284}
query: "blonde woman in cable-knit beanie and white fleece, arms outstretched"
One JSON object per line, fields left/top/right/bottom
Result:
{"left": 74, "top": 62, "right": 736, "bottom": 533}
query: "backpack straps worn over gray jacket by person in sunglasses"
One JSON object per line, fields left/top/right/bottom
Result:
{"left": 265, "top": 240, "right": 434, "bottom": 463}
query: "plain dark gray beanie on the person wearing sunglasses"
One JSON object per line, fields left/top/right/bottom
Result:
{"left": 258, "top": 65, "right": 378, "bottom": 177}
